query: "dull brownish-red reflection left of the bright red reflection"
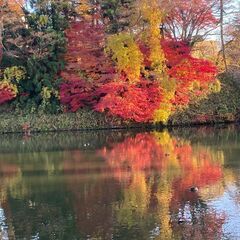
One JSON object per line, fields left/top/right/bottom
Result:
{"left": 63, "top": 150, "right": 119, "bottom": 239}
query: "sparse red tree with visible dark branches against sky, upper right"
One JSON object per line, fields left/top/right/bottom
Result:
{"left": 163, "top": 0, "right": 218, "bottom": 44}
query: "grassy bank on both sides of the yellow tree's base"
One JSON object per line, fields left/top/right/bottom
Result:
{"left": 0, "top": 73, "right": 240, "bottom": 133}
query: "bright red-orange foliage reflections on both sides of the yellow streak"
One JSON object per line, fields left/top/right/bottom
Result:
{"left": 101, "top": 133, "right": 222, "bottom": 192}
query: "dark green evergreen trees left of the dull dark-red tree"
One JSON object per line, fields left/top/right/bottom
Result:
{"left": 0, "top": 0, "right": 73, "bottom": 112}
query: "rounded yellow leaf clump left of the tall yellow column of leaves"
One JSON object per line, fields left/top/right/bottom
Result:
{"left": 106, "top": 33, "right": 143, "bottom": 83}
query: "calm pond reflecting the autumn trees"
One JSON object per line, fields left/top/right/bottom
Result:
{"left": 0, "top": 125, "right": 240, "bottom": 240}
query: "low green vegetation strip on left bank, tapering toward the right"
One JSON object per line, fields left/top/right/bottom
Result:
{"left": 0, "top": 108, "right": 124, "bottom": 133}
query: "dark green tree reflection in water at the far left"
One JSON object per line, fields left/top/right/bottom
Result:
{"left": 0, "top": 152, "right": 81, "bottom": 239}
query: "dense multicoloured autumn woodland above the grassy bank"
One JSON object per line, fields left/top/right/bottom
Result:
{"left": 0, "top": 0, "right": 240, "bottom": 123}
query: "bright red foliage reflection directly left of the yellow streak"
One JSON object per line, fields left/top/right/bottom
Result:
{"left": 100, "top": 133, "right": 167, "bottom": 179}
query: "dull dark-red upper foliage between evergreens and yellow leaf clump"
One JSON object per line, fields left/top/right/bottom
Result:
{"left": 64, "top": 21, "right": 115, "bottom": 82}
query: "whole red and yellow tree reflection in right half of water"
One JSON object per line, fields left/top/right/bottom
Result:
{"left": 97, "top": 131, "right": 223, "bottom": 239}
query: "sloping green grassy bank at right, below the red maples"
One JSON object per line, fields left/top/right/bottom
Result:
{"left": 169, "top": 75, "right": 240, "bottom": 125}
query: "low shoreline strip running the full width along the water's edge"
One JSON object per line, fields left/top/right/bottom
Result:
{"left": 0, "top": 109, "right": 239, "bottom": 135}
